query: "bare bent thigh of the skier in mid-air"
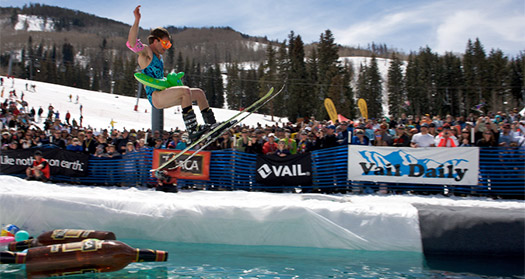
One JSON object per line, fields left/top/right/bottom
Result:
{"left": 151, "top": 86, "right": 192, "bottom": 109}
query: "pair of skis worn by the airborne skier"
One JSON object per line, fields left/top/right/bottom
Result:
{"left": 151, "top": 87, "right": 284, "bottom": 178}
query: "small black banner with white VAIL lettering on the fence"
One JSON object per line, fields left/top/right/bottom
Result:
{"left": 256, "top": 154, "right": 312, "bottom": 186}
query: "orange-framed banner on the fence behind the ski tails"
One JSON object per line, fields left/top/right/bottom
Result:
{"left": 153, "top": 149, "right": 211, "bottom": 180}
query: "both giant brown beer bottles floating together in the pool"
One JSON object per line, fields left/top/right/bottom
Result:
{"left": 0, "top": 229, "right": 168, "bottom": 278}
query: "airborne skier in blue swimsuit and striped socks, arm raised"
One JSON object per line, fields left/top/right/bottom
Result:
{"left": 126, "top": 5, "right": 216, "bottom": 141}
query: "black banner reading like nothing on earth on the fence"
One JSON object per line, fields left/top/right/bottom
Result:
{"left": 0, "top": 148, "right": 89, "bottom": 176}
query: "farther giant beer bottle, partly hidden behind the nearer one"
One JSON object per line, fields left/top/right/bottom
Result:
{"left": 7, "top": 229, "right": 117, "bottom": 252}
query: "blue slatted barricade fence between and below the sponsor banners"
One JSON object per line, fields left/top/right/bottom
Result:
{"left": 2, "top": 146, "right": 525, "bottom": 198}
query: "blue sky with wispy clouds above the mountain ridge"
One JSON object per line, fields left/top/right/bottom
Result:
{"left": 0, "top": 0, "right": 525, "bottom": 56}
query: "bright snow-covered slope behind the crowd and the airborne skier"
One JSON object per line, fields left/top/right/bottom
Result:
{"left": 0, "top": 77, "right": 286, "bottom": 131}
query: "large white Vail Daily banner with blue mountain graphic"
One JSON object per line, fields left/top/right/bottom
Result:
{"left": 348, "top": 145, "right": 479, "bottom": 185}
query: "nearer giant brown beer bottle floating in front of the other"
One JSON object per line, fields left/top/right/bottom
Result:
{"left": 0, "top": 239, "right": 168, "bottom": 278}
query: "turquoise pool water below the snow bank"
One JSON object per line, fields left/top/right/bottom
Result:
{"left": 0, "top": 239, "right": 525, "bottom": 279}
